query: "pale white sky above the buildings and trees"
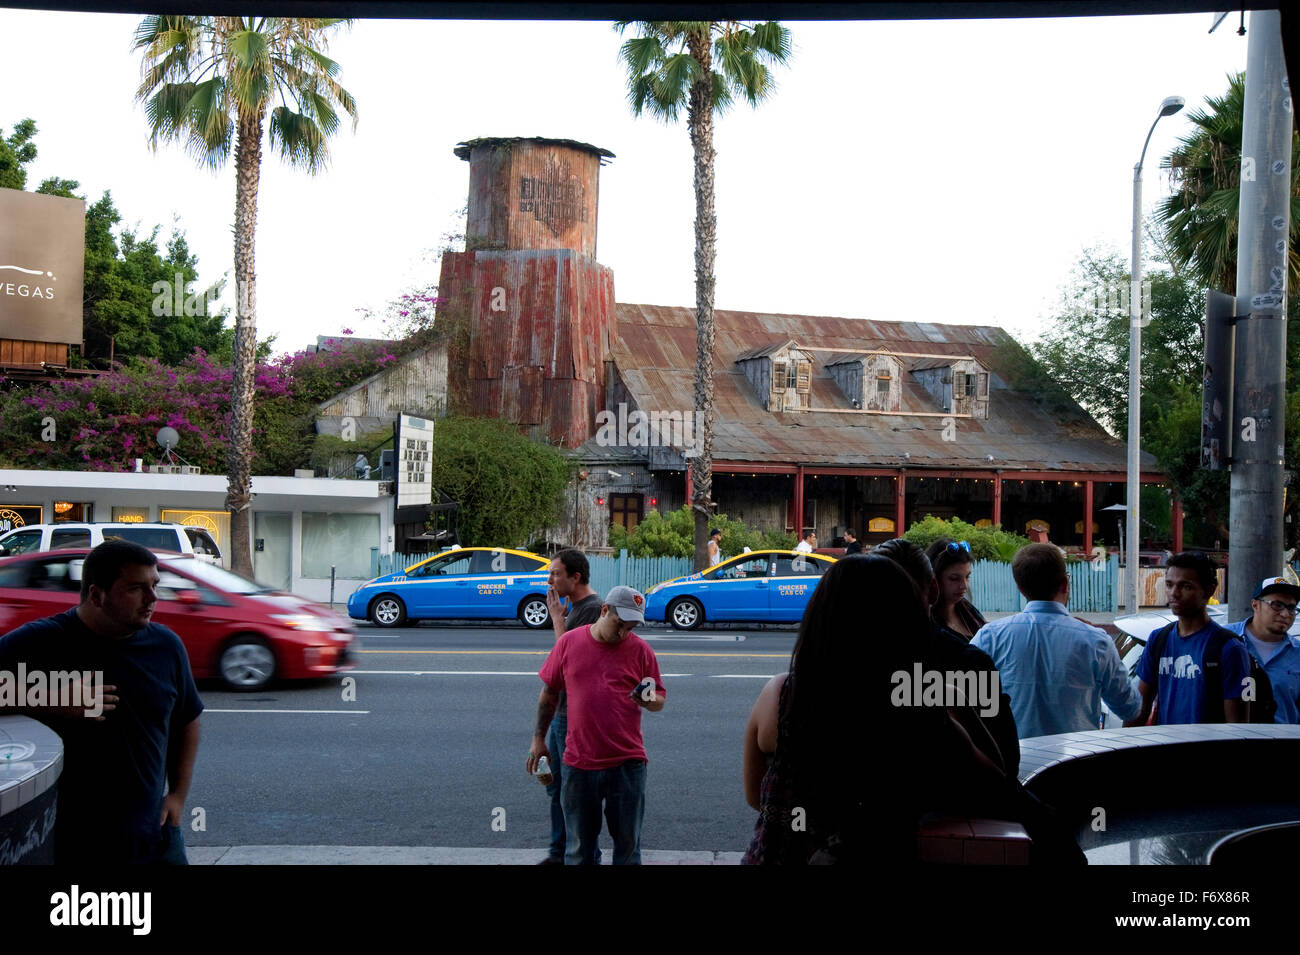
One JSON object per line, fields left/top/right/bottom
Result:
{"left": 0, "top": 9, "right": 1249, "bottom": 350}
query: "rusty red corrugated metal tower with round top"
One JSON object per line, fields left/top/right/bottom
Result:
{"left": 438, "top": 139, "right": 616, "bottom": 447}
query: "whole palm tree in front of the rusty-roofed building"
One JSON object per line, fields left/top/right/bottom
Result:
{"left": 615, "top": 19, "right": 790, "bottom": 570}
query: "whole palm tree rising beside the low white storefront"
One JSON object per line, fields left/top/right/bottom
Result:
{"left": 134, "top": 16, "right": 356, "bottom": 577}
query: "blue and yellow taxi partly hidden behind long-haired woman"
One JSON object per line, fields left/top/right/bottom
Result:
{"left": 646, "top": 551, "right": 835, "bottom": 630}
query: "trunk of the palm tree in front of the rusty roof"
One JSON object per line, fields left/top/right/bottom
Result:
{"left": 686, "top": 30, "right": 718, "bottom": 570}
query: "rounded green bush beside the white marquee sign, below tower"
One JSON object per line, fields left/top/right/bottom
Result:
{"left": 432, "top": 417, "right": 572, "bottom": 547}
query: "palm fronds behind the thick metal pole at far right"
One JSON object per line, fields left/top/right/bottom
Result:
{"left": 1156, "top": 73, "right": 1300, "bottom": 295}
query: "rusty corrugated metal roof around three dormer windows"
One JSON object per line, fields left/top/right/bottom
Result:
{"left": 610, "top": 304, "right": 1157, "bottom": 472}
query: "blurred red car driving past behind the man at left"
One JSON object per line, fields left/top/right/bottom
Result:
{"left": 0, "top": 550, "right": 356, "bottom": 690}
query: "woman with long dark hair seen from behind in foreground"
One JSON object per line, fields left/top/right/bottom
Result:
{"left": 745, "top": 555, "right": 976, "bottom": 865}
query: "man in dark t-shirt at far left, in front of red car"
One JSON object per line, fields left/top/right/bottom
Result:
{"left": 0, "top": 541, "right": 203, "bottom": 865}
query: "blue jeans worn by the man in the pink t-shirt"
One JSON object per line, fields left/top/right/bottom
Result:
{"left": 563, "top": 759, "right": 646, "bottom": 865}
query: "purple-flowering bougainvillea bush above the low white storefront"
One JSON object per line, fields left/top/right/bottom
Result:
{"left": 0, "top": 343, "right": 397, "bottom": 474}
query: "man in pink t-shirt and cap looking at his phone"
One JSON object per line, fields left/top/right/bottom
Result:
{"left": 525, "top": 586, "right": 667, "bottom": 865}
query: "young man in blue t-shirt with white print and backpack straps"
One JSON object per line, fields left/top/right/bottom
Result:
{"left": 1125, "top": 551, "right": 1251, "bottom": 726}
